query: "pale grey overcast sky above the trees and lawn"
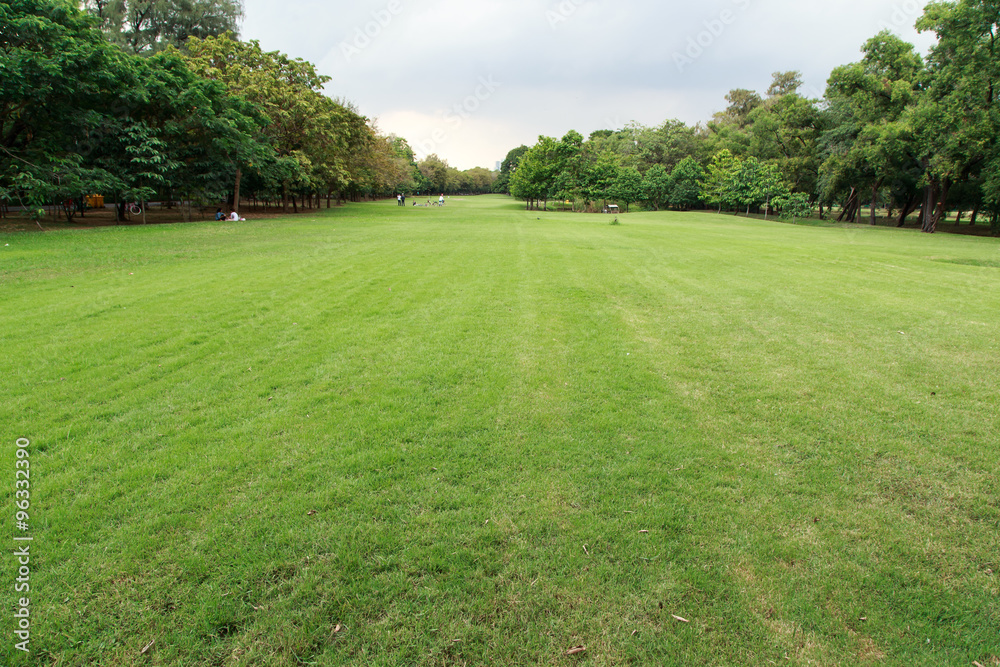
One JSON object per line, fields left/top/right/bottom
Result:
{"left": 242, "top": 0, "right": 933, "bottom": 169}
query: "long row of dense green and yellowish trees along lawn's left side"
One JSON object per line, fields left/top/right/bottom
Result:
{"left": 0, "top": 0, "right": 493, "bottom": 220}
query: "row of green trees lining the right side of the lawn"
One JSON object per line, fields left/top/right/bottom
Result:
{"left": 496, "top": 0, "right": 1000, "bottom": 232}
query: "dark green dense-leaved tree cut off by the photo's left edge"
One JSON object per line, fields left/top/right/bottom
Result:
{"left": 0, "top": 0, "right": 131, "bottom": 213}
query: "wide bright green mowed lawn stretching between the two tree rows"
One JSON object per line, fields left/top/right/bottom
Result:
{"left": 0, "top": 197, "right": 1000, "bottom": 666}
